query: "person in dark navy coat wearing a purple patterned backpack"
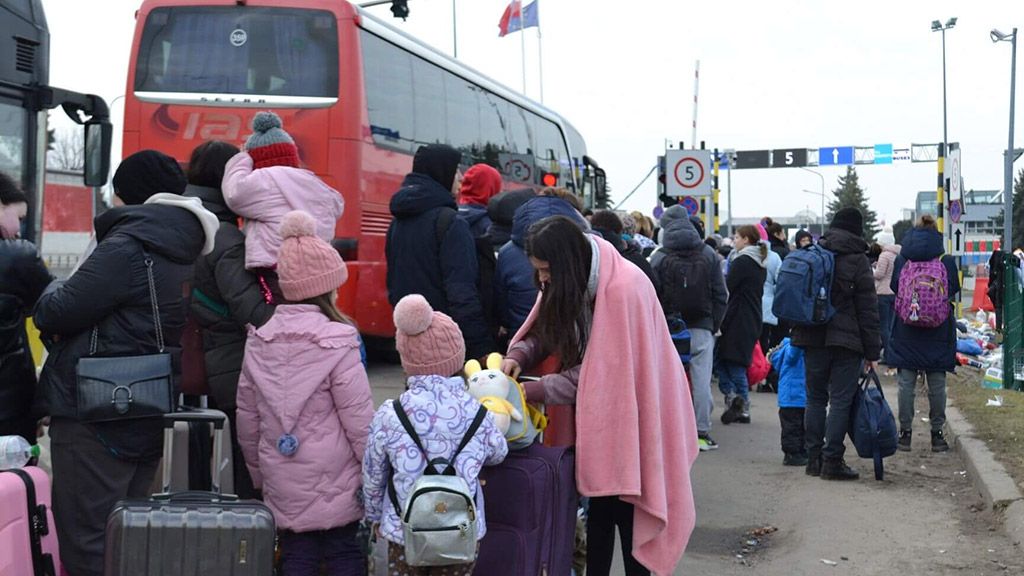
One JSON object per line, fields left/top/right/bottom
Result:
{"left": 886, "top": 214, "right": 961, "bottom": 452}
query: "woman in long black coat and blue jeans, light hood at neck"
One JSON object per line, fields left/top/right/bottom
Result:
{"left": 715, "top": 225, "right": 768, "bottom": 424}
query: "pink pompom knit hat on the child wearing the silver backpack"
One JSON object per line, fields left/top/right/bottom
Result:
{"left": 394, "top": 294, "right": 466, "bottom": 377}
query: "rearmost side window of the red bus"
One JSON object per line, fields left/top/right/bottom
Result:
{"left": 362, "top": 33, "right": 416, "bottom": 153}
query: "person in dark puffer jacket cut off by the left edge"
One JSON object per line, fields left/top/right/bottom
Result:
{"left": 0, "top": 172, "right": 51, "bottom": 444}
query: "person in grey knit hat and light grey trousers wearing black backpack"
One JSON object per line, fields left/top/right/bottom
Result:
{"left": 651, "top": 205, "right": 729, "bottom": 451}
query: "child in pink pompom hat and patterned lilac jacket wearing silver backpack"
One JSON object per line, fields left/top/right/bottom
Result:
{"left": 362, "top": 294, "right": 508, "bottom": 576}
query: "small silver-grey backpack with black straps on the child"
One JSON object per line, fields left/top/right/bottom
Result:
{"left": 388, "top": 399, "right": 487, "bottom": 566}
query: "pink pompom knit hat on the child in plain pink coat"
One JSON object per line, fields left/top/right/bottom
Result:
{"left": 278, "top": 210, "right": 348, "bottom": 302}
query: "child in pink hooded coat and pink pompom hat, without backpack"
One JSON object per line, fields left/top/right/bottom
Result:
{"left": 238, "top": 211, "right": 374, "bottom": 576}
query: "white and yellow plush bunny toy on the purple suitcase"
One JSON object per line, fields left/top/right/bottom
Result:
{"left": 465, "top": 354, "right": 548, "bottom": 450}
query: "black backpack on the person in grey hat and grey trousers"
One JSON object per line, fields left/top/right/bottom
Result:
{"left": 652, "top": 245, "right": 712, "bottom": 324}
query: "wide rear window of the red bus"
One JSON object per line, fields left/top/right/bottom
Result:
{"left": 135, "top": 6, "right": 338, "bottom": 98}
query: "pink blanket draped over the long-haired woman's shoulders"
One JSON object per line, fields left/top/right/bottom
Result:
{"left": 512, "top": 239, "right": 698, "bottom": 575}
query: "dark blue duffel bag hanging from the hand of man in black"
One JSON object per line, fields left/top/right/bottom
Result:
{"left": 850, "top": 370, "right": 899, "bottom": 480}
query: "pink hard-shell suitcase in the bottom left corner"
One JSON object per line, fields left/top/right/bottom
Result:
{"left": 0, "top": 466, "right": 61, "bottom": 576}
